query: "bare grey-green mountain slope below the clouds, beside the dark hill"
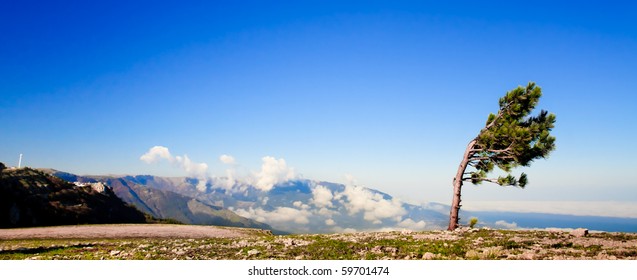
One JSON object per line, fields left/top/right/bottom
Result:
{"left": 45, "top": 169, "right": 275, "bottom": 231}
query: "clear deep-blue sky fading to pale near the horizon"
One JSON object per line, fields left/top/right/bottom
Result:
{"left": 0, "top": 1, "right": 637, "bottom": 212}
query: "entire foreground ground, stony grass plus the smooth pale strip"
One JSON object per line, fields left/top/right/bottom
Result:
{"left": 0, "top": 225, "right": 637, "bottom": 260}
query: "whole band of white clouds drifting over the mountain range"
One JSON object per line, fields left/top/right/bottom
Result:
{"left": 139, "top": 146, "right": 427, "bottom": 232}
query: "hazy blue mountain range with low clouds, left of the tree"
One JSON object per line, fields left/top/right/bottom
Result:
{"left": 48, "top": 172, "right": 447, "bottom": 233}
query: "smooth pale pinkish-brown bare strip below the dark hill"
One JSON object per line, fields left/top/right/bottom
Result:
{"left": 0, "top": 224, "right": 265, "bottom": 240}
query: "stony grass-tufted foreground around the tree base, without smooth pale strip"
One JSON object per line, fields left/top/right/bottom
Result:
{"left": 0, "top": 228, "right": 637, "bottom": 260}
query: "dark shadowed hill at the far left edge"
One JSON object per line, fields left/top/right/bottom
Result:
{"left": 0, "top": 168, "right": 147, "bottom": 228}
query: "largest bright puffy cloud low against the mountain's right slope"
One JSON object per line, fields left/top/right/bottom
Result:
{"left": 336, "top": 186, "right": 407, "bottom": 223}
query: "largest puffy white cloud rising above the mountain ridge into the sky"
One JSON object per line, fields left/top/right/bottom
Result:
{"left": 254, "top": 156, "right": 295, "bottom": 192}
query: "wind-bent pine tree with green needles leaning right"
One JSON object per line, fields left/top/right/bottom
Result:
{"left": 448, "top": 82, "right": 555, "bottom": 230}
